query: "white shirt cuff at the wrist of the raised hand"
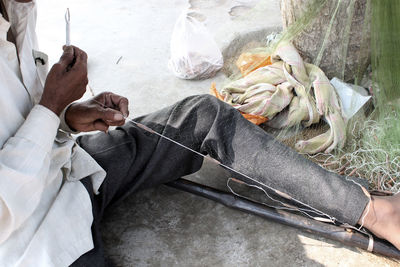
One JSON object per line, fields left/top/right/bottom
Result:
{"left": 15, "top": 105, "right": 60, "bottom": 154}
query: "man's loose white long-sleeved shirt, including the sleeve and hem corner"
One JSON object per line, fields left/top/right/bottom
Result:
{"left": 0, "top": 0, "right": 105, "bottom": 266}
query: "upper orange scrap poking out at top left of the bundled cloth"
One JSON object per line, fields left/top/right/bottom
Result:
{"left": 236, "top": 52, "right": 272, "bottom": 77}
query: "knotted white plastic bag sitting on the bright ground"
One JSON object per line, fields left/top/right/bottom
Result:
{"left": 168, "top": 10, "right": 224, "bottom": 80}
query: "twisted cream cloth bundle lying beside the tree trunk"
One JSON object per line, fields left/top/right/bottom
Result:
{"left": 220, "top": 43, "right": 346, "bottom": 154}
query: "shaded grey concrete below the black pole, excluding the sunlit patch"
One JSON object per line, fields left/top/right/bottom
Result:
{"left": 103, "top": 162, "right": 323, "bottom": 266}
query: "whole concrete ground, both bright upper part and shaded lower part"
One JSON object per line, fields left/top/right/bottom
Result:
{"left": 38, "top": 0, "right": 397, "bottom": 266}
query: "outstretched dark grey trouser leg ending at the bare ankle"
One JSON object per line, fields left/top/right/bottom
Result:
{"left": 122, "top": 96, "right": 369, "bottom": 225}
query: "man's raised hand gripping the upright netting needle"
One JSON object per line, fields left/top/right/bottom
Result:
{"left": 39, "top": 46, "right": 88, "bottom": 116}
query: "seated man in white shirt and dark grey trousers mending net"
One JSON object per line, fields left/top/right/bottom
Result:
{"left": 0, "top": 0, "right": 400, "bottom": 266}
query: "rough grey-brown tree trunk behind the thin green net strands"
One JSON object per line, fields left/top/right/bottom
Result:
{"left": 281, "top": 0, "right": 370, "bottom": 81}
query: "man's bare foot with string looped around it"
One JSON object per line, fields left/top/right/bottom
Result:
{"left": 359, "top": 194, "right": 400, "bottom": 250}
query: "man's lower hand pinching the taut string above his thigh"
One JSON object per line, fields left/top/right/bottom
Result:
{"left": 65, "top": 92, "right": 129, "bottom": 132}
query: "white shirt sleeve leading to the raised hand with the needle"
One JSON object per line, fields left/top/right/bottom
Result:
{"left": 0, "top": 105, "right": 60, "bottom": 244}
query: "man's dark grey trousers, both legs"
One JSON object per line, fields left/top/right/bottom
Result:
{"left": 73, "top": 95, "right": 369, "bottom": 266}
